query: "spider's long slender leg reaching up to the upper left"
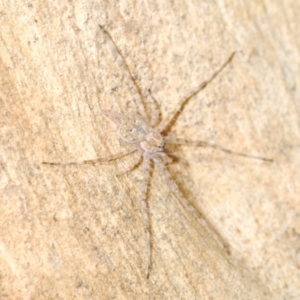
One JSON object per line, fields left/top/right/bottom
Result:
{"left": 99, "top": 25, "right": 148, "bottom": 121}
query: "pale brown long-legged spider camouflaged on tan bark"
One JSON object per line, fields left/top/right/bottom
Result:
{"left": 42, "top": 25, "right": 272, "bottom": 278}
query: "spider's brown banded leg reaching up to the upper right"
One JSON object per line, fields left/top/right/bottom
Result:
{"left": 157, "top": 52, "right": 235, "bottom": 132}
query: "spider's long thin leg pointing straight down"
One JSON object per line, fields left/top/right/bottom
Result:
{"left": 141, "top": 155, "right": 152, "bottom": 278}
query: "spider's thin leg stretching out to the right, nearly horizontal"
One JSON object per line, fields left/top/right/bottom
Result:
{"left": 165, "top": 136, "right": 273, "bottom": 162}
